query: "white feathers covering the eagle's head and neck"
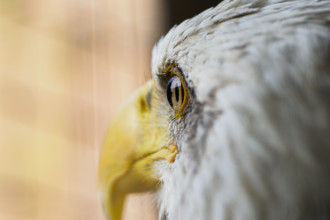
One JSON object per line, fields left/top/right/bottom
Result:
{"left": 152, "top": 0, "right": 330, "bottom": 220}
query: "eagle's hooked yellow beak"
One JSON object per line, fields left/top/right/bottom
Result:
{"left": 99, "top": 82, "right": 178, "bottom": 220}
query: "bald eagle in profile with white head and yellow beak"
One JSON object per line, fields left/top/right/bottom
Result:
{"left": 99, "top": 0, "right": 330, "bottom": 220}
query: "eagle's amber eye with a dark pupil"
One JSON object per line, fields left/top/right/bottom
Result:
{"left": 166, "top": 75, "right": 187, "bottom": 116}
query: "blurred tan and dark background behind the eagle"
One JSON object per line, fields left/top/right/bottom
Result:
{"left": 0, "top": 0, "right": 219, "bottom": 220}
